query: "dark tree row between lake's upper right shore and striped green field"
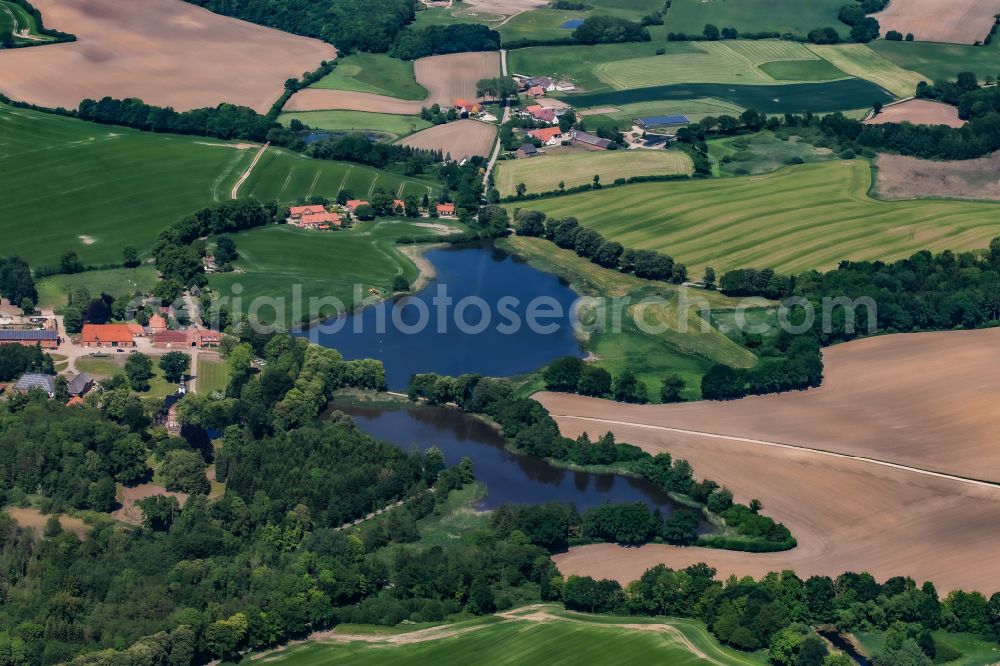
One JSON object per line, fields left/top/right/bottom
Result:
{"left": 514, "top": 209, "right": 687, "bottom": 284}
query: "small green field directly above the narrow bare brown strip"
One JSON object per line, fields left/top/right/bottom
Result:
{"left": 312, "top": 53, "right": 427, "bottom": 100}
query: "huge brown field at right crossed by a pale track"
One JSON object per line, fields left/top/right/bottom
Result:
{"left": 537, "top": 329, "right": 1000, "bottom": 592}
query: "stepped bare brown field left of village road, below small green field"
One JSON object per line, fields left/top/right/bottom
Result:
{"left": 285, "top": 51, "right": 500, "bottom": 115}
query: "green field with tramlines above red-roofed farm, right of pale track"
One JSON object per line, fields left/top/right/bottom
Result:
{"left": 239, "top": 148, "right": 435, "bottom": 203}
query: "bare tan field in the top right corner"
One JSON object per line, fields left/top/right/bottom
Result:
{"left": 872, "top": 0, "right": 1000, "bottom": 44}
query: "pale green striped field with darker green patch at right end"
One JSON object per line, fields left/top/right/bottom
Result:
{"left": 594, "top": 40, "right": 845, "bottom": 90}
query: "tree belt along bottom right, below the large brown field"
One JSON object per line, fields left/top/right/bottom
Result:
{"left": 562, "top": 564, "right": 1000, "bottom": 666}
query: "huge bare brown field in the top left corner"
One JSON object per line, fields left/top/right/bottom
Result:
{"left": 0, "top": 0, "right": 336, "bottom": 112}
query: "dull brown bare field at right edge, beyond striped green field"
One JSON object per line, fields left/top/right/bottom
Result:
{"left": 876, "top": 152, "right": 1000, "bottom": 201}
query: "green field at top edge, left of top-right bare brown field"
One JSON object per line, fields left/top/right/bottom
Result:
{"left": 666, "top": 0, "right": 846, "bottom": 36}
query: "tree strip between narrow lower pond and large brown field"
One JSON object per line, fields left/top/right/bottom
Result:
{"left": 409, "top": 374, "right": 795, "bottom": 551}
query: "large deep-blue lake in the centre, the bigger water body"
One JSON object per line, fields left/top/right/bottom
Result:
{"left": 305, "top": 244, "right": 583, "bottom": 389}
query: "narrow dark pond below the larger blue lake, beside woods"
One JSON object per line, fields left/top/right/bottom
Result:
{"left": 332, "top": 404, "right": 700, "bottom": 515}
